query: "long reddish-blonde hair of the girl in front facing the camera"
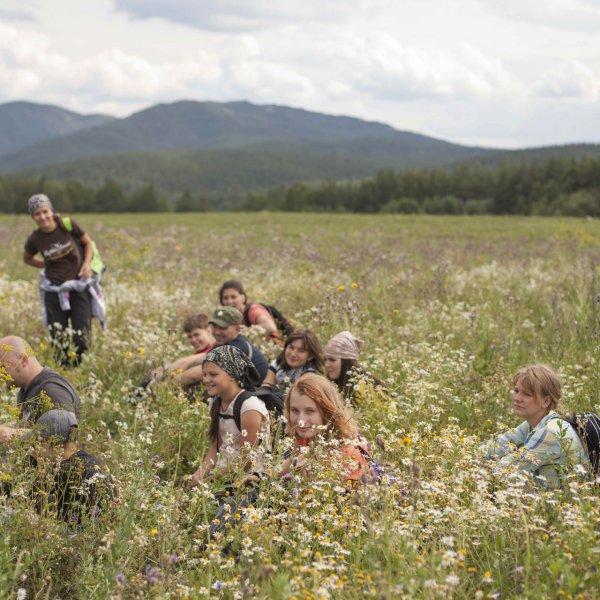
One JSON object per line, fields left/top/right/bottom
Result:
{"left": 284, "top": 373, "right": 358, "bottom": 440}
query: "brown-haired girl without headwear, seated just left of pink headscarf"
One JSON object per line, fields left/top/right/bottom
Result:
{"left": 264, "top": 329, "right": 323, "bottom": 394}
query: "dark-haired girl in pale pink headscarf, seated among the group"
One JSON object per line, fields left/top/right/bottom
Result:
{"left": 323, "top": 331, "right": 387, "bottom": 406}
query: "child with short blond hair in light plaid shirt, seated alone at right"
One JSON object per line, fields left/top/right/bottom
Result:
{"left": 482, "top": 365, "right": 589, "bottom": 487}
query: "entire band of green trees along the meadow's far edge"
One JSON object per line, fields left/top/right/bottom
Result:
{"left": 0, "top": 156, "right": 600, "bottom": 217}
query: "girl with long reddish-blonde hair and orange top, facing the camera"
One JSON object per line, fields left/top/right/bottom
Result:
{"left": 279, "top": 373, "right": 369, "bottom": 481}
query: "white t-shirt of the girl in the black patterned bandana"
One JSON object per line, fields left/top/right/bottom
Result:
{"left": 208, "top": 392, "right": 271, "bottom": 473}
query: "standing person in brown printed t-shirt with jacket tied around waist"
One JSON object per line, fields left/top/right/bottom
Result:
{"left": 23, "top": 194, "right": 98, "bottom": 366}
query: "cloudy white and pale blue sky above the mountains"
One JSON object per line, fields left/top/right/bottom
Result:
{"left": 0, "top": 0, "right": 600, "bottom": 148}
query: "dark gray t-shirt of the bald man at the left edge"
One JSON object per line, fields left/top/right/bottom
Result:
{"left": 17, "top": 367, "right": 81, "bottom": 426}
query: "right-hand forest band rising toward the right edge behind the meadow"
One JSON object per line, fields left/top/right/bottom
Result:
{"left": 240, "top": 157, "right": 600, "bottom": 217}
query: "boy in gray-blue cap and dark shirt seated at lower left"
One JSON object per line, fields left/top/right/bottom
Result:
{"left": 34, "top": 409, "right": 115, "bottom": 525}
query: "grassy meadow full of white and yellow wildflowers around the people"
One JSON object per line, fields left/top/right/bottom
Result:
{"left": 0, "top": 213, "right": 600, "bottom": 600}
